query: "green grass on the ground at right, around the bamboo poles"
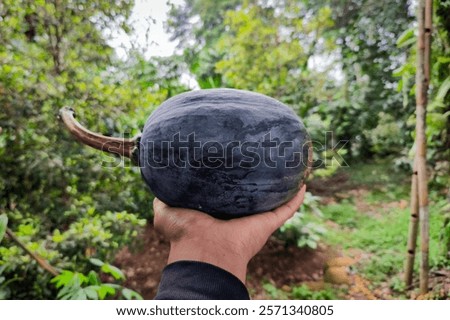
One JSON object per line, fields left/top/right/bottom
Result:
{"left": 263, "top": 159, "right": 450, "bottom": 299}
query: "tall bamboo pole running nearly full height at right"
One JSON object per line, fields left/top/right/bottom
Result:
{"left": 412, "top": 0, "right": 432, "bottom": 294}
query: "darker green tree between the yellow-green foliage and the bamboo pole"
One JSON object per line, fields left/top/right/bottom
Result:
{"left": 315, "top": 0, "right": 413, "bottom": 158}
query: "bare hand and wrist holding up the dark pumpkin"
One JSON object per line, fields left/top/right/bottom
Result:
{"left": 153, "top": 186, "right": 306, "bottom": 283}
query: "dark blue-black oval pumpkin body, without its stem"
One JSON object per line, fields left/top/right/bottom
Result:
{"left": 139, "top": 89, "right": 311, "bottom": 219}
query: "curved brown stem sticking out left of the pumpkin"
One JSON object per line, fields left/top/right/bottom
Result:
{"left": 59, "top": 107, "right": 140, "bottom": 163}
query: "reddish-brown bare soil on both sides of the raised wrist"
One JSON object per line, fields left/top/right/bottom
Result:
{"left": 115, "top": 224, "right": 328, "bottom": 299}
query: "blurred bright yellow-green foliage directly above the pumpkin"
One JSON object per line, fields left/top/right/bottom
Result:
{"left": 216, "top": 3, "right": 333, "bottom": 105}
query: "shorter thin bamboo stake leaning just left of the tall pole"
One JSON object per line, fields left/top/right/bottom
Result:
{"left": 405, "top": 159, "right": 419, "bottom": 288}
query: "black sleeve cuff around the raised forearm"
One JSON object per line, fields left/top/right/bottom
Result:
{"left": 155, "top": 261, "right": 250, "bottom": 300}
